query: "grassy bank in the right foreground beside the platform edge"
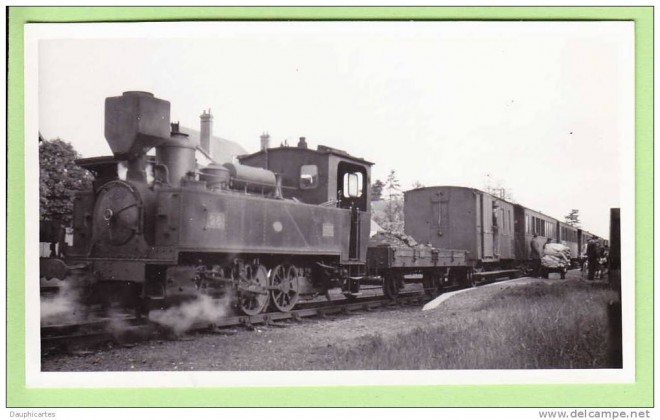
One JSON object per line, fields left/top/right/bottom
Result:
{"left": 328, "top": 281, "right": 620, "bottom": 369}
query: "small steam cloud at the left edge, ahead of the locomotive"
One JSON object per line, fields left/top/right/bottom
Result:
{"left": 41, "top": 279, "right": 84, "bottom": 326}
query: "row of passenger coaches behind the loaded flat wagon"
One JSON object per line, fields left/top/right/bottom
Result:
{"left": 404, "top": 186, "right": 607, "bottom": 272}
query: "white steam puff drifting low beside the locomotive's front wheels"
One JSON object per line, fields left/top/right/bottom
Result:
{"left": 149, "top": 295, "right": 231, "bottom": 335}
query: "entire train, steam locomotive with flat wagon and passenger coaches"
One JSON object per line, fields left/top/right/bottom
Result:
{"left": 41, "top": 91, "right": 608, "bottom": 315}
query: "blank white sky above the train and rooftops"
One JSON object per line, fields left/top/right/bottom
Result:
{"left": 37, "top": 22, "right": 634, "bottom": 237}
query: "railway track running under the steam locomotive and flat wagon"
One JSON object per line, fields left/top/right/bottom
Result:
{"left": 41, "top": 291, "right": 428, "bottom": 355}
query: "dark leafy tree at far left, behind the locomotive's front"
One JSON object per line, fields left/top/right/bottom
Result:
{"left": 39, "top": 138, "right": 93, "bottom": 225}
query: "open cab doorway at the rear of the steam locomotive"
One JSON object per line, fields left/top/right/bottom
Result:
{"left": 337, "top": 162, "right": 367, "bottom": 259}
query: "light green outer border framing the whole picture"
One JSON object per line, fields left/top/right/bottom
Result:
{"left": 7, "top": 7, "right": 653, "bottom": 407}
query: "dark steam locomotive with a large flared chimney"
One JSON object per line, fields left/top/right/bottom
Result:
{"left": 60, "top": 92, "right": 372, "bottom": 315}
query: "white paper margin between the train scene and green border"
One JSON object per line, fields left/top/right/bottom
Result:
{"left": 25, "top": 22, "right": 635, "bottom": 388}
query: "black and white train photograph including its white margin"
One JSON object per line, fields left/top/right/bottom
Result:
{"left": 25, "top": 21, "right": 635, "bottom": 386}
